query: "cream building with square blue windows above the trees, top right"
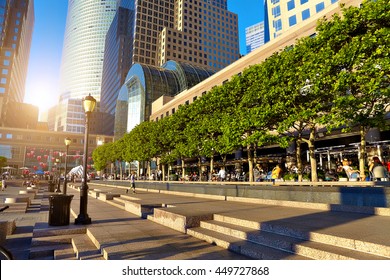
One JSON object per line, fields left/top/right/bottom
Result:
{"left": 264, "top": 0, "right": 338, "bottom": 42}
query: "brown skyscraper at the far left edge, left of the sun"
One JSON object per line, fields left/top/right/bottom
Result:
{"left": 0, "top": 0, "right": 34, "bottom": 125}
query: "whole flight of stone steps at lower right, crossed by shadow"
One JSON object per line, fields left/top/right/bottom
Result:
{"left": 187, "top": 215, "right": 390, "bottom": 260}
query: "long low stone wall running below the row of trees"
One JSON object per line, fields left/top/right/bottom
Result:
{"left": 92, "top": 181, "right": 390, "bottom": 208}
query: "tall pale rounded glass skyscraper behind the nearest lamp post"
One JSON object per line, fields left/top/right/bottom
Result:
{"left": 55, "top": 0, "right": 117, "bottom": 133}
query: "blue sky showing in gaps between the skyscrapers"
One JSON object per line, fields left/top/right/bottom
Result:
{"left": 24, "top": 0, "right": 264, "bottom": 111}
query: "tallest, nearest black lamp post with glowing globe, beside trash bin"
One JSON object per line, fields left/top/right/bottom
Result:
{"left": 75, "top": 95, "right": 96, "bottom": 225}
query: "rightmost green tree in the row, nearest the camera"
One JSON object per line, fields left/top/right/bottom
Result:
{"left": 319, "top": 0, "right": 390, "bottom": 174}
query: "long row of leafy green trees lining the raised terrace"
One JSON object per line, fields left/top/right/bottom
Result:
{"left": 93, "top": 0, "right": 390, "bottom": 181}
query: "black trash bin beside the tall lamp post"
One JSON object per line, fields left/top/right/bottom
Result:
{"left": 49, "top": 194, "right": 73, "bottom": 226}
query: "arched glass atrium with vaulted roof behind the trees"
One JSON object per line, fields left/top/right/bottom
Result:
{"left": 114, "top": 61, "right": 215, "bottom": 139}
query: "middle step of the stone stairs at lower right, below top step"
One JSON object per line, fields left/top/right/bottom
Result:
{"left": 201, "top": 221, "right": 387, "bottom": 260}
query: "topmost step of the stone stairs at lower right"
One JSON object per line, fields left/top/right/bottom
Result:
{"left": 214, "top": 214, "right": 390, "bottom": 259}
